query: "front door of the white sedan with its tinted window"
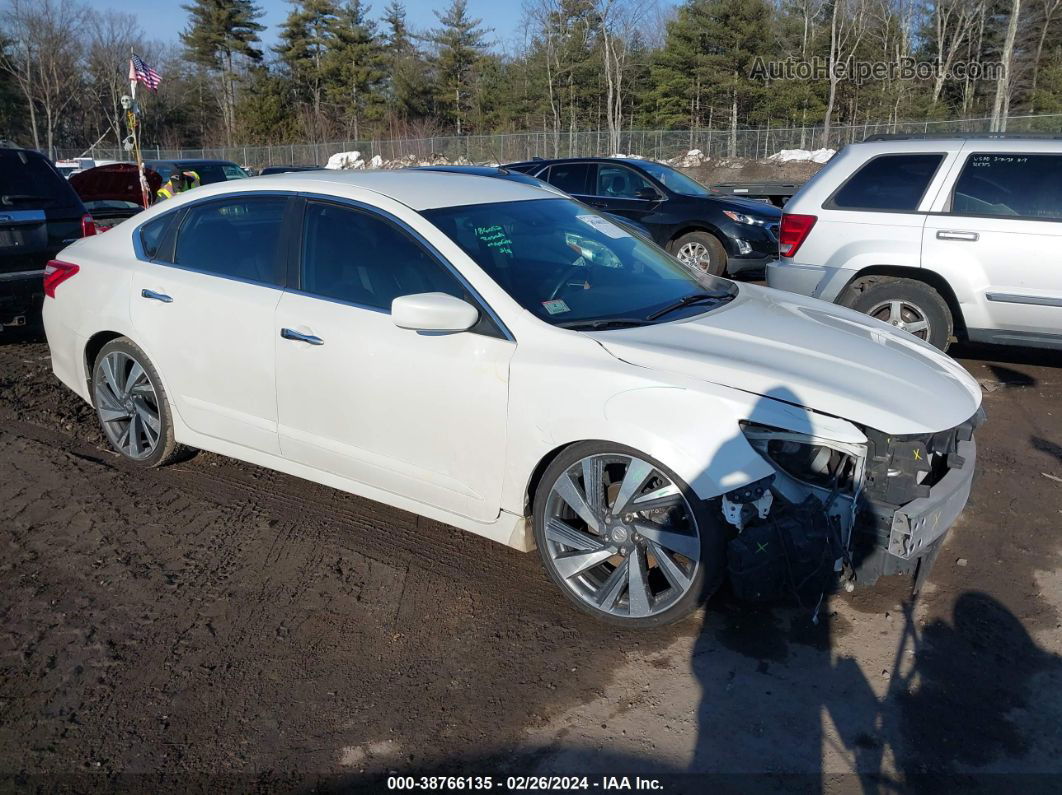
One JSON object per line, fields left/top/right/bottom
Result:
{"left": 273, "top": 201, "right": 516, "bottom": 521}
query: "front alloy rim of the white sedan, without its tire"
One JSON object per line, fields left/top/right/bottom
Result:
{"left": 544, "top": 453, "right": 701, "bottom": 618}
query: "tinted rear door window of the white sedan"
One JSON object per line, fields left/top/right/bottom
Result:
{"left": 174, "top": 196, "right": 288, "bottom": 284}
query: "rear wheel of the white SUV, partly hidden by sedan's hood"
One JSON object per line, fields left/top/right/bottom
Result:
{"left": 838, "top": 276, "right": 955, "bottom": 350}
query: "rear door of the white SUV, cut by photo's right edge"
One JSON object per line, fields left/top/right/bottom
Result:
{"left": 922, "top": 145, "right": 1062, "bottom": 343}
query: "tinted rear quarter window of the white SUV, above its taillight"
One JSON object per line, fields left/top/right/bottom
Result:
{"left": 832, "top": 155, "right": 944, "bottom": 211}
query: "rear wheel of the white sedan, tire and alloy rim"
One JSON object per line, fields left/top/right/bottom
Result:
{"left": 92, "top": 336, "right": 186, "bottom": 468}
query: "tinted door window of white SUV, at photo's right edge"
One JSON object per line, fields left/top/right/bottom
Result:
{"left": 952, "top": 154, "right": 1062, "bottom": 220}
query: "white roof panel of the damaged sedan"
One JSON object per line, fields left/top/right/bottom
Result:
{"left": 231, "top": 169, "right": 556, "bottom": 210}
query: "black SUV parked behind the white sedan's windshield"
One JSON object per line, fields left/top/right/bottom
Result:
{"left": 504, "top": 157, "right": 782, "bottom": 275}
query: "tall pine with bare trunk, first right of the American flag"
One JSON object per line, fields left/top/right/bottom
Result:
{"left": 181, "top": 0, "right": 266, "bottom": 144}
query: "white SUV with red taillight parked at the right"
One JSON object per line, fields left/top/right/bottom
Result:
{"left": 767, "top": 135, "right": 1062, "bottom": 349}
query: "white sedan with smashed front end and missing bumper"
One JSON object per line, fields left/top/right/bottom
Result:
{"left": 45, "top": 171, "right": 982, "bottom": 626}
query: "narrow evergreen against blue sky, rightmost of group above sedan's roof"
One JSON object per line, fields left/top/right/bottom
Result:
{"left": 430, "top": 0, "right": 490, "bottom": 135}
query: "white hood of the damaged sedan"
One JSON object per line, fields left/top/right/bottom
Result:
{"left": 589, "top": 284, "right": 981, "bottom": 435}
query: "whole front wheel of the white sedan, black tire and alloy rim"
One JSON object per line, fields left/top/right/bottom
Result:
{"left": 533, "top": 442, "right": 726, "bottom": 628}
